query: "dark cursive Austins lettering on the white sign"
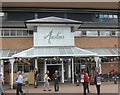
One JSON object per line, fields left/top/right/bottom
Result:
{"left": 44, "top": 30, "right": 64, "bottom": 44}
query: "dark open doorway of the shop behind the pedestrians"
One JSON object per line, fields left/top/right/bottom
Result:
{"left": 47, "top": 65, "right": 62, "bottom": 80}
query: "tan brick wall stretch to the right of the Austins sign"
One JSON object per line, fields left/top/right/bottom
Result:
{"left": 75, "top": 37, "right": 118, "bottom": 48}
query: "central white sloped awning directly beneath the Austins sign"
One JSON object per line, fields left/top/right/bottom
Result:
{"left": 12, "top": 47, "right": 97, "bottom": 58}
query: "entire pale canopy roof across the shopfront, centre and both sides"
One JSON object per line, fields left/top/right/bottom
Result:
{"left": 0, "top": 47, "right": 120, "bottom": 59}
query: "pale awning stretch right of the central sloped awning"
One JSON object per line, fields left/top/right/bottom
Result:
{"left": 85, "top": 48, "right": 120, "bottom": 56}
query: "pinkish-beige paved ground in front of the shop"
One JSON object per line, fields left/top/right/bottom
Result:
{"left": 5, "top": 82, "right": 120, "bottom": 95}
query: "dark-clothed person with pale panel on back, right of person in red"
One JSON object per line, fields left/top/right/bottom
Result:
{"left": 95, "top": 72, "right": 101, "bottom": 95}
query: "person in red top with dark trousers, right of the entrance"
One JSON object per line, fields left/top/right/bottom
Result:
{"left": 81, "top": 70, "right": 90, "bottom": 95}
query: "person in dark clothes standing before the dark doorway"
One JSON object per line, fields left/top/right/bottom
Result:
{"left": 52, "top": 70, "right": 60, "bottom": 92}
